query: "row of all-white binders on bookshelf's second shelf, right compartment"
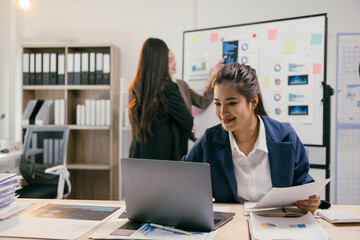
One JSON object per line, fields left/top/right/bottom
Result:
{"left": 76, "top": 99, "right": 111, "bottom": 126}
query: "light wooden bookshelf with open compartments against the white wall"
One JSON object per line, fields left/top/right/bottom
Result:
{"left": 22, "top": 44, "right": 120, "bottom": 200}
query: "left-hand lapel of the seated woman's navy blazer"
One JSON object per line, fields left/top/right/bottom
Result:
{"left": 213, "top": 127, "right": 237, "bottom": 199}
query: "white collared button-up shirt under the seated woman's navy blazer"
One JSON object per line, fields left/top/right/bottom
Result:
{"left": 229, "top": 117, "right": 272, "bottom": 202}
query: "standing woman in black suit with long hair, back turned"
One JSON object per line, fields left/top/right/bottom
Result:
{"left": 129, "top": 38, "right": 193, "bottom": 160}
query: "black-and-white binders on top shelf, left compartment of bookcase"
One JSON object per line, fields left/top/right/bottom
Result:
{"left": 23, "top": 53, "right": 65, "bottom": 85}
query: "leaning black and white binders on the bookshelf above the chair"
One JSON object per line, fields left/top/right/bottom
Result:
{"left": 22, "top": 99, "right": 65, "bottom": 126}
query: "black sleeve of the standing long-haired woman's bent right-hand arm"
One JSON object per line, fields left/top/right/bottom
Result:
{"left": 165, "top": 82, "right": 193, "bottom": 131}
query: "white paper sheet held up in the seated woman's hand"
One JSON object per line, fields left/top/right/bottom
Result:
{"left": 253, "top": 178, "right": 331, "bottom": 208}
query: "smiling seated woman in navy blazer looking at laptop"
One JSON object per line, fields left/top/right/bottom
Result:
{"left": 183, "top": 63, "right": 320, "bottom": 212}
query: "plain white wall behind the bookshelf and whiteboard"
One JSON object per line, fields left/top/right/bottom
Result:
{"left": 0, "top": 0, "right": 360, "bottom": 202}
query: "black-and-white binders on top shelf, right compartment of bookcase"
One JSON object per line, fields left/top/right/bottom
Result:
{"left": 67, "top": 52, "right": 110, "bottom": 85}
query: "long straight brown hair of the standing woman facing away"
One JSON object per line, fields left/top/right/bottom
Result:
{"left": 129, "top": 38, "right": 171, "bottom": 142}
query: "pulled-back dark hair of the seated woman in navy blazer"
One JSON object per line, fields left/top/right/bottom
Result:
{"left": 212, "top": 63, "right": 267, "bottom": 116}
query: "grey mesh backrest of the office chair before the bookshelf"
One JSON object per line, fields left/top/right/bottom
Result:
{"left": 19, "top": 126, "right": 69, "bottom": 184}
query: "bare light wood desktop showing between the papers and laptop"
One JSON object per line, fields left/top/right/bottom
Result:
{"left": 0, "top": 199, "right": 360, "bottom": 240}
